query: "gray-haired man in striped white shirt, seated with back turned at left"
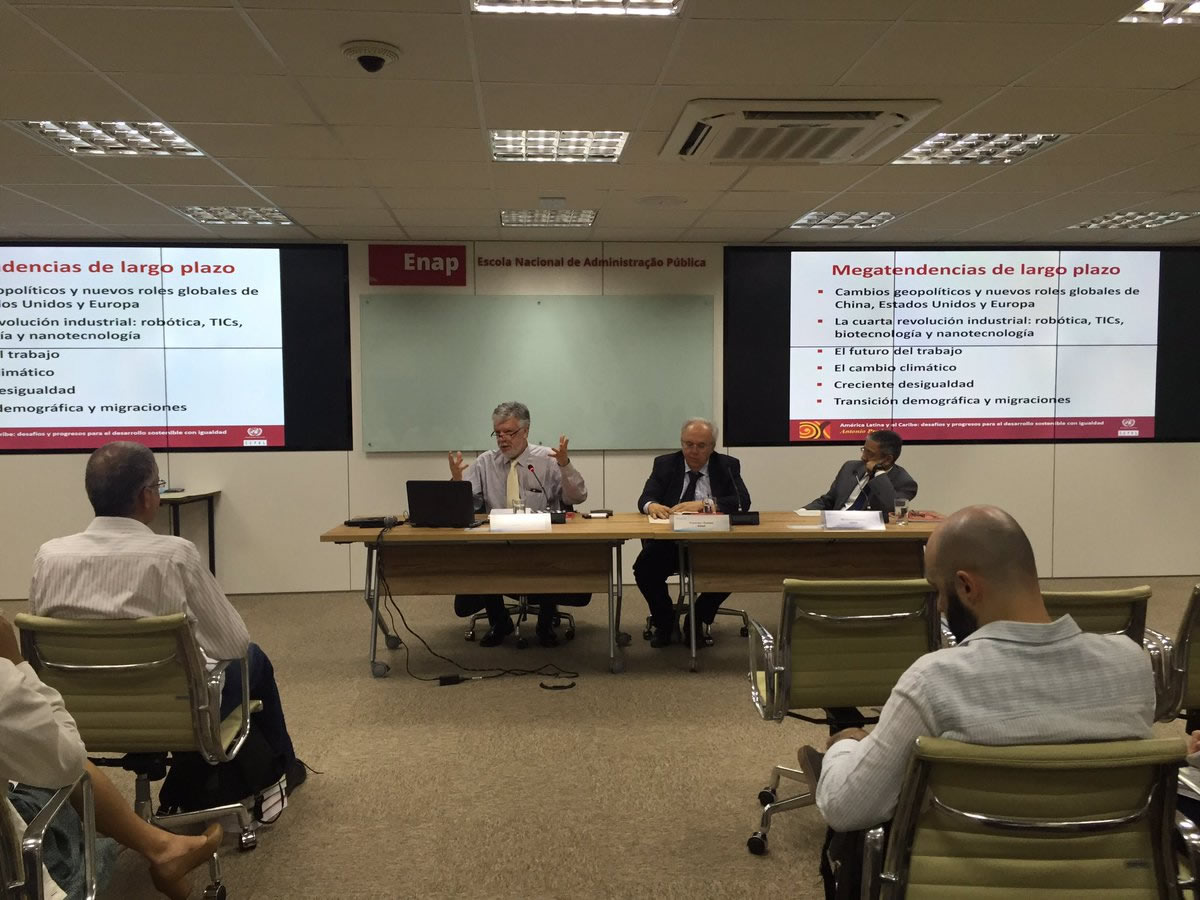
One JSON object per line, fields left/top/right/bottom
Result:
{"left": 29, "top": 442, "right": 306, "bottom": 806}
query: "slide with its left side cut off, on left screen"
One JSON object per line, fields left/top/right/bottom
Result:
{"left": 0, "top": 246, "right": 284, "bottom": 450}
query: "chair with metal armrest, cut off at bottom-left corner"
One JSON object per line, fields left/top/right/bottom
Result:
{"left": 0, "top": 772, "right": 96, "bottom": 900}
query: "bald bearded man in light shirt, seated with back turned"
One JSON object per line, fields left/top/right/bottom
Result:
{"left": 816, "top": 506, "right": 1154, "bottom": 896}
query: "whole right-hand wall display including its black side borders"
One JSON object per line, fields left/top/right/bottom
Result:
{"left": 725, "top": 248, "right": 1198, "bottom": 444}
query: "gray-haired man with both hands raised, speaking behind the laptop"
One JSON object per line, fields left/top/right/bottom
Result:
{"left": 448, "top": 402, "right": 592, "bottom": 647}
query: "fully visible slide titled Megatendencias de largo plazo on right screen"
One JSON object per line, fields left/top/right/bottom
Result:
{"left": 788, "top": 248, "right": 1160, "bottom": 443}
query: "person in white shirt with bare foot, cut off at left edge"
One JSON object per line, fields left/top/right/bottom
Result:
{"left": 0, "top": 616, "right": 221, "bottom": 900}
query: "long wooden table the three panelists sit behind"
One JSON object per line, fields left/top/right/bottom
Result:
{"left": 320, "top": 512, "right": 932, "bottom": 678}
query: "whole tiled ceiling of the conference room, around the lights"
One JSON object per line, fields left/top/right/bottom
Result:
{"left": 0, "top": 0, "right": 1200, "bottom": 244}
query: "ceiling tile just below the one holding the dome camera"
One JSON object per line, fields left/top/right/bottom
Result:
{"left": 301, "top": 78, "right": 479, "bottom": 128}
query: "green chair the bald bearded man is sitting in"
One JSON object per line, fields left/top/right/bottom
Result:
{"left": 862, "top": 737, "right": 1200, "bottom": 900}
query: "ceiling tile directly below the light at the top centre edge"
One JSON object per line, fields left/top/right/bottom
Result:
{"left": 470, "top": 16, "right": 679, "bottom": 84}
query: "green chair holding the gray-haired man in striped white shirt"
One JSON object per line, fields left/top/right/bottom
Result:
{"left": 16, "top": 613, "right": 262, "bottom": 900}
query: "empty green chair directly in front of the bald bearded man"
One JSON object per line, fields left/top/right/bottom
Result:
{"left": 746, "top": 578, "right": 940, "bottom": 854}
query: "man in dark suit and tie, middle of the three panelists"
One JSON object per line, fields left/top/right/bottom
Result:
{"left": 634, "top": 419, "right": 750, "bottom": 647}
